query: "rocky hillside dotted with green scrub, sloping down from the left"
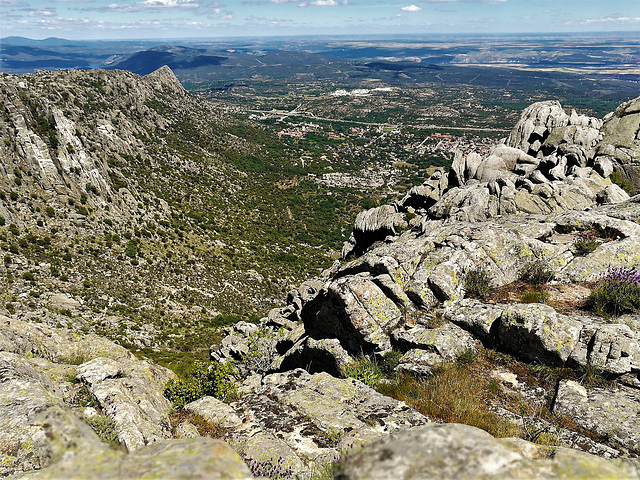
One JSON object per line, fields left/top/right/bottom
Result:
{"left": 0, "top": 68, "right": 410, "bottom": 362}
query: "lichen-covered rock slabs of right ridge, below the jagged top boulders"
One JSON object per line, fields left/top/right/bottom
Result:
{"left": 212, "top": 201, "right": 640, "bottom": 375}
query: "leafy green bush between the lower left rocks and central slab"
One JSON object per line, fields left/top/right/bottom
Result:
{"left": 164, "top": 362, "right": 237, "bottom": 408}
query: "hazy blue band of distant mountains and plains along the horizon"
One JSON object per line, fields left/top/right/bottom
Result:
{"left": 0, "top": 32, "right": 640, "bottom": 77}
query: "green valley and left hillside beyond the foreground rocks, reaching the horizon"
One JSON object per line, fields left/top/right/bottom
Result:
{"left": 0, "top": 32, "right": 637, "bottom": 372}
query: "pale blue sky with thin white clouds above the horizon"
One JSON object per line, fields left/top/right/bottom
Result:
{"left": 0, "top": 0, "right": 640, "bottom": 39}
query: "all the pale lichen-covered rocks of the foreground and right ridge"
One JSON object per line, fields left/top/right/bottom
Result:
{"left": 0, "top": 99, "right": 640, "bottom": 479}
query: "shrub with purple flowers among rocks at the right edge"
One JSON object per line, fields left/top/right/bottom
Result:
{"left": 587, "top": 267, "right": 640, "bottom": 317}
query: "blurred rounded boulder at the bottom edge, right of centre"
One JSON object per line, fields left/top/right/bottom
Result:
{"left": 340, "top": 424, "right": 639, "bottom": 480}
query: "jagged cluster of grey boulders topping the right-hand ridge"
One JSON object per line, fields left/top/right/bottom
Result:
{"left": 342, "top": 99, "right": 640, "bottom": 258}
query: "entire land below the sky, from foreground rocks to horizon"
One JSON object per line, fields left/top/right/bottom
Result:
{"left": 0, "top": 34, "right": 640, "bottom": 480}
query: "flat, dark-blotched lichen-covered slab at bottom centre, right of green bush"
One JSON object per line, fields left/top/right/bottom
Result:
{"left": 185, "top": 369, "right": 428, "bottom": 474}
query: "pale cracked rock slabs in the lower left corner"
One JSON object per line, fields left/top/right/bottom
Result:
{"left": 0, "top": 317, "right": 188, "bottom": 478}
